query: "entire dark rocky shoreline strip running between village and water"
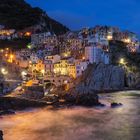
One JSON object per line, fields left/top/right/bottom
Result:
{"left": 0, "top": 93, "right": 102, "bottom": 116}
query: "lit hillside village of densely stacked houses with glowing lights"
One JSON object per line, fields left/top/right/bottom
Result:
{"left": 0, "top": 25, "right": 140, "bottom": 96}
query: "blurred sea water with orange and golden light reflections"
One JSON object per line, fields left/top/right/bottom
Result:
{"left": 0, "top": 91, "right": 140, "bottom": 140}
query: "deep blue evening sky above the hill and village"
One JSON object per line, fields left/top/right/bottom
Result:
{"left": 26, "top": 0, "right": 140, "bottom": 35}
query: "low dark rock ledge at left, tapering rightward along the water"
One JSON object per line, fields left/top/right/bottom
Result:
{"left": 0, "top": 97, "right": 47, "bottom": 111}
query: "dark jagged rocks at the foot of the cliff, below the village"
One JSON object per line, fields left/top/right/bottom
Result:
{"left": 44, "top": 92, "right": 101, "bottom": 107}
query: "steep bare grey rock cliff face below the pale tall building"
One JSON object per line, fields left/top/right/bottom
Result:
{"left": 71, "top": 63, "right": 125, "bottom": 93}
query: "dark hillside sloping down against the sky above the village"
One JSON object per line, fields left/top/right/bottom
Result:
{"left": 0, "top": 0, "right": 69, "bottom": 34}
